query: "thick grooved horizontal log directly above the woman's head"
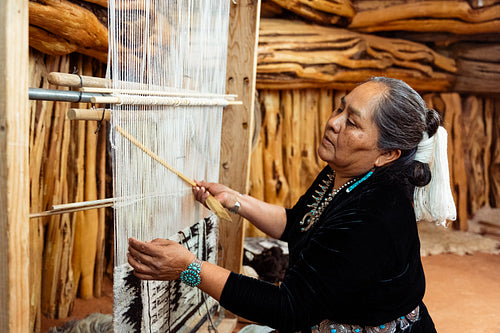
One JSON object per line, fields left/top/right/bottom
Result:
{"left": 257, "top": 19, "right": 456, "bottom": 91}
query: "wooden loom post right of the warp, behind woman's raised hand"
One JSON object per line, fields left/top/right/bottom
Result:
{"left": 219, "top": 0, "right": 260, "bottom": 272}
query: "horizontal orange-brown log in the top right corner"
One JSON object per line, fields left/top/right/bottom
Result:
{"left": 349, "top": 0, "right": 500, "bottom": 35}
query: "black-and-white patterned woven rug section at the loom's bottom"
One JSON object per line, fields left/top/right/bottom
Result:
{"left": 113, "top": 214, "right": 218, "bottom": 333}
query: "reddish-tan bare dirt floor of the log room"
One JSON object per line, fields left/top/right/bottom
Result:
{"left": 42, "top": 253, "right": 500, "bottom": 333}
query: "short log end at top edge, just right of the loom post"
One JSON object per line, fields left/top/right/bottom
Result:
{"left": 267, "top": 0, "right": 354, "bottom": 26}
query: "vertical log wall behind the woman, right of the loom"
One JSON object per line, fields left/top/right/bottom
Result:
{"left": 249, "top": 89, "right": 500, "bottom": 232}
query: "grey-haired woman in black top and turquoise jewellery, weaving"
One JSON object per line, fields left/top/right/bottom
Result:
{"left": 129, "top": 78, "right": 454, "bottom": 333}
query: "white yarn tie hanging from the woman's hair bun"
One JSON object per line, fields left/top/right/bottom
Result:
{"left": 413, "top": 126, "right": 457, "bottom": 227}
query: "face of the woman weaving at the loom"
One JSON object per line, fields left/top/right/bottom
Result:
{"left": 318, "top": 82, "right": 394, "bottom": 178}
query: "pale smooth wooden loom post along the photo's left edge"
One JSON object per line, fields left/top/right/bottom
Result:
{"left": 0, "top": 0, "right": 30, "bottom": 332}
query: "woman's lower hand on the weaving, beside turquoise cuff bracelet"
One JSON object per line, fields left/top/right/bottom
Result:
{"left": 127, "top": 238, "right": 195, "bottom": 281}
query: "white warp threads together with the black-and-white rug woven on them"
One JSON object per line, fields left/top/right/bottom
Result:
{"left": 105, "top": 0, "right": 229, "bottom": 332}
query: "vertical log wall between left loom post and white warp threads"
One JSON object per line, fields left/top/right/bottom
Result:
{"left": 29, "top": 50, "right": 106, "bottom": 331}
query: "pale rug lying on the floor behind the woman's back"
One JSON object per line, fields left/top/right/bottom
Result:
{"left": 418, "top": 222, "right": 500, "bottom": 256}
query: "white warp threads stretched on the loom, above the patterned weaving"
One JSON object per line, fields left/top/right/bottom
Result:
{"left": 108, "top": 0, "right": 230, "bottom": 265}
